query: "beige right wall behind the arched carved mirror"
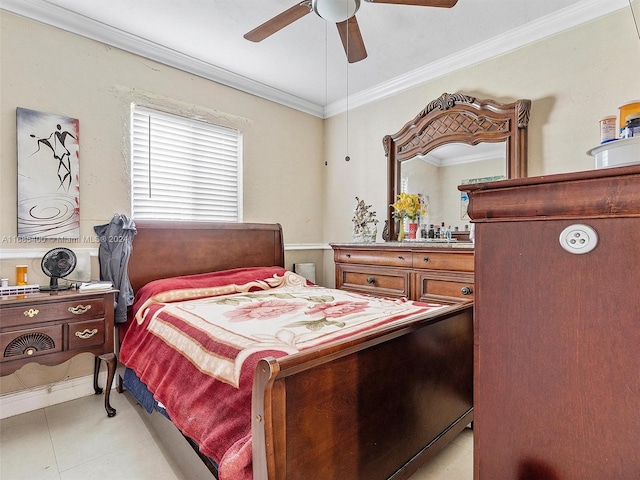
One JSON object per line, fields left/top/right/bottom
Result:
{"left": 324, "top": 9, "right": 640, "bottom": 251}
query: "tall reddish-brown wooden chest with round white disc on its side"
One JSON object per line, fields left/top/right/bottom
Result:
{"left": 461, "top": 166, "right": 640, "bottom": 480}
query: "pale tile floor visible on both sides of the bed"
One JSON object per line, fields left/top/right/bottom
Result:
{"left": 0, "top": 391, "right": 473, "bottom": 480}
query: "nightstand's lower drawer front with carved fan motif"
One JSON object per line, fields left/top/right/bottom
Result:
{"left": 0, "top": 325, "right": 63, "bottom": 362}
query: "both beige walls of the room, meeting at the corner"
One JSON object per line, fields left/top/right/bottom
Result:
{"left": 0, "top": 10, "right": 640, "bottom": 392}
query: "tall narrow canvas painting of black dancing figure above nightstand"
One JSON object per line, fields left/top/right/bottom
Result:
{"left": 16, "top": 107, "right": 80, "bottom": 239}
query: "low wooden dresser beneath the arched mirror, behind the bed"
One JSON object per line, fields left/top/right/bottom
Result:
{"left": 331, "top": 242, "right": 474, "bottom": 303}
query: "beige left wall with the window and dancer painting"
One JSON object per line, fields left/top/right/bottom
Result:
{"left": 0, "top": 11, "right": 324, "bottom": 392}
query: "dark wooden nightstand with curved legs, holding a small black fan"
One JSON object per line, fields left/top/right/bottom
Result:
{"left": 0, "top": 290, "right": 116, "bottom": 417}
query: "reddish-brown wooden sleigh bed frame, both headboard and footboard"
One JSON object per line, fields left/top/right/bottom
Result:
{"left": 129, "top": 222, "right": 473, "bottom": 480}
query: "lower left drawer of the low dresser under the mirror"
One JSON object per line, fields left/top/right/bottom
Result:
{"left": 336, "top": 265, "right": 410, "bottom": 297}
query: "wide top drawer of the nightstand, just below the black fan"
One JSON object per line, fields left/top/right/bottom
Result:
{"left": 2, "top": 298, "right": 104, "bottom": 328}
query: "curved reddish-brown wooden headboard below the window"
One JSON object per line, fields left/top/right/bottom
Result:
{"left": 128, "top": 221, "right": 284, "bottom": 291}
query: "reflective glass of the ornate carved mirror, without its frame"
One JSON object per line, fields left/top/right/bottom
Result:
{"left": 400, "top": 142, "right": 506, "bottom": 231}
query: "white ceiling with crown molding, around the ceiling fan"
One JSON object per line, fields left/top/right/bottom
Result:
{"left": 1, "top": 0, "right": 629, "bottom": 117}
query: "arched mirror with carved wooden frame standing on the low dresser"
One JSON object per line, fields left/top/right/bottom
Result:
{"left": 383, "top": 93, "right": 531, "bottom": 240}
